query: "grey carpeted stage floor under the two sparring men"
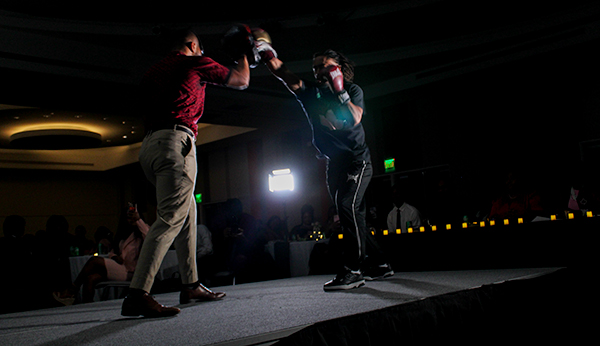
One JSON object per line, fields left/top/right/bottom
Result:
{"left": 0, "top": 268, "right": 560, "bottom": 346}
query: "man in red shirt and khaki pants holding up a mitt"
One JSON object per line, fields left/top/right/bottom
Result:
{"left": 121, "top": 28, "right": 254, "bottom": 317}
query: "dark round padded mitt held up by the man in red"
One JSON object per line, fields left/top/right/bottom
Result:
{"left": 221, "top": 24, "right": 260, "bottom": 68}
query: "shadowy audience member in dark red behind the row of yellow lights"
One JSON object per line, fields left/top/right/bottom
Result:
{"left": 489, "top": 170, "right": 543, "bottom": 221}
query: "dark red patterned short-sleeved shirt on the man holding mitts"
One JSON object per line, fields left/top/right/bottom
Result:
{"left": 142, "top": 52, "right": 230, "bottom": 135}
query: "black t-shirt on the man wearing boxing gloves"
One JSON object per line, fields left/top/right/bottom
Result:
{"left": 296, "top": 81, "right": 371, "bottom": 163}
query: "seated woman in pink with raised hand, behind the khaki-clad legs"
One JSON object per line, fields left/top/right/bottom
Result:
{"left": 73, "top": 207, "right": 150, "bottom": 303}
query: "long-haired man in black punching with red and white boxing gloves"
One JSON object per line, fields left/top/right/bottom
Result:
{"left": 255, "top": 32, "right": 394, "bottom": 291}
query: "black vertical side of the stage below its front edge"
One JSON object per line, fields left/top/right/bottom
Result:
{"left": 275, "top": 269, "right": 581, "bottom": 346}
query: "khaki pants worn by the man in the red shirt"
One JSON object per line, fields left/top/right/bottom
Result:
{"left": 130, "top": 129, "right": 198, "bottom": 292}
